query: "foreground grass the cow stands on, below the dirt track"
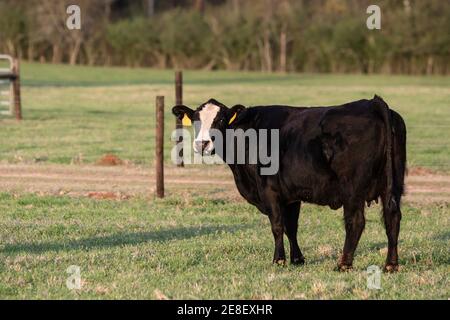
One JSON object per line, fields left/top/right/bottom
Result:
{"left": 0, "top": 194, "right": 450, "bottom": 299}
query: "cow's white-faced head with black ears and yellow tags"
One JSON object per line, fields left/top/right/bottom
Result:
{"left": 172, "top": 99, "right": 245, "bottom": 154}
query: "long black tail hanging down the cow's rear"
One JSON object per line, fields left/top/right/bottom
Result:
{"left": 373, "top": 96, "right": 406, "bottom": 212}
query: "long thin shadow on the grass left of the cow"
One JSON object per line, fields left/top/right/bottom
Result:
{"left": 0, "top": 224, "right": 252, "bottom": 254}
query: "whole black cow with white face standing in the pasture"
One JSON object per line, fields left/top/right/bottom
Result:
{"left": 172, "top": 96, "right": 406, "bottom": 271}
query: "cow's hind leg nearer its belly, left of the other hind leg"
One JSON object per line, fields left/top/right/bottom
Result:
{"left": 339, "top": 201, "right": 366, "bottom": 271}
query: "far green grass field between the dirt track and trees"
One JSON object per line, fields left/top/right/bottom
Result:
{"left": 0, "top": 63, "right": 450, "bottom": 172}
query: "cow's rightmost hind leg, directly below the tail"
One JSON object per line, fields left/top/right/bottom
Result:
{"left": 383, "top": 201, "right": 402, "bottom": 272}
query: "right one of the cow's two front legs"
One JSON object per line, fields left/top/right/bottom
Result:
{"left": 283, "top": 202, "right": 305, "bottom": 264}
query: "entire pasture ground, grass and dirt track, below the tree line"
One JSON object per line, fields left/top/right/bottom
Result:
{"left": 0, "top": 64, "right": 450, "bottom": 299}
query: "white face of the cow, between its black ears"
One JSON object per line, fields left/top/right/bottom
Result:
{"left": 193, "top": 103, "right": 220, "bottom": 154}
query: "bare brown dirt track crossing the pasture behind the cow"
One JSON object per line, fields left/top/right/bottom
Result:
{"left": 0, "top": 163, "right": 450, "bottom": 203}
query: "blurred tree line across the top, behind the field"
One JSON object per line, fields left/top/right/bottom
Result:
{"left": 0, "top": 0, "right": 450, "bottom": 74}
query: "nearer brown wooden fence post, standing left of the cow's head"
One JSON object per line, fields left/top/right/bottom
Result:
{"left": 155, "top": 96, "right": 164, "bottom": 198}
